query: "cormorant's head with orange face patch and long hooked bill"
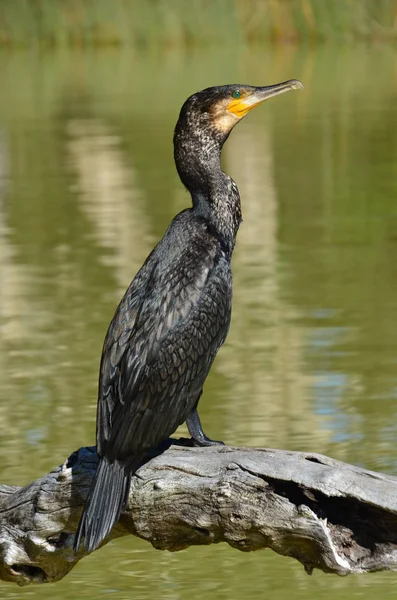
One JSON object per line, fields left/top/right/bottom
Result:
{"left": 177, "top": 79, "right": 303, "bottom": 142}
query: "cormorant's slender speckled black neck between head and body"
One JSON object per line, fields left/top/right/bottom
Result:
{"left": 174, "top": 131, "right": 241, "bottom": 254}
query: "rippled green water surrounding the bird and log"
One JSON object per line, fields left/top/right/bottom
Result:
{"left": 0, "top": 46, "right": 397, "bottom": 600}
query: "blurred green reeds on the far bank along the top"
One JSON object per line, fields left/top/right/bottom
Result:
{"left": 0, "top": 0, "right": 397, "bottom": 46}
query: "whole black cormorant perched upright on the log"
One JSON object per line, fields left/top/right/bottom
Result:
{"left": 74, "top": 80, "right": 302, "bottom": 552}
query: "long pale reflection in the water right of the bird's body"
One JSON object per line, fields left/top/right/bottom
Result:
{"left": 217, "top": 124, "right": 328, "bottom": 447}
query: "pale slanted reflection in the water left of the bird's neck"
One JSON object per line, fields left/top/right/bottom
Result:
{"left": 68, "top": 119, "right": 150, "bottom": 294}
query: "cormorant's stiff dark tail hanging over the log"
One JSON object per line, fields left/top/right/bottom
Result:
{"left": 73, "top": 458, "right": 131, "bottom": 552}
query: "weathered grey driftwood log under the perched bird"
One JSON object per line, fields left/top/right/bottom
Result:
{"left": 0, "top": 441, "right": 397, "bottom": 585}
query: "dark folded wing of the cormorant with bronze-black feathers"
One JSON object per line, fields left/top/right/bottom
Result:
{"left": 97, "top": 233, "right": 223, "bottom": 460}
